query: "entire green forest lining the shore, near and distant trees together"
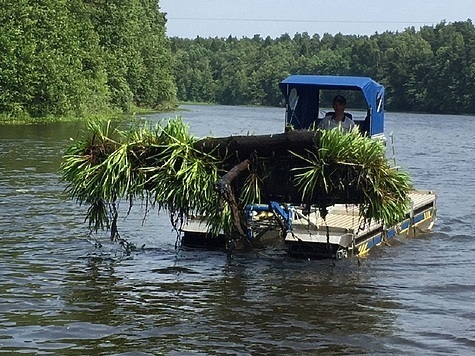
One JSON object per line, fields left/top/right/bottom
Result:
{"left": 0, "top": 0, "right": 475, "bottom": 118}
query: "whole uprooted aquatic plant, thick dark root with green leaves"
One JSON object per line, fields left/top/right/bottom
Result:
{"left": 61, "top": 118, "right": 411, "bottom": 246}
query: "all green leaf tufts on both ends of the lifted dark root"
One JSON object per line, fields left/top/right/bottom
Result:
{"left": 61, "top": 119, "right": 411, "bottom": 239}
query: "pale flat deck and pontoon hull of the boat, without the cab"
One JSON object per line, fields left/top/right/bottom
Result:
{"left": 182, "top": 191, "right": 436, "bottom": 258}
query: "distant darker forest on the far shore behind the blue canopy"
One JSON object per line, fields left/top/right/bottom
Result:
{"left": 171, "top": 20, "right": 475, "bottom": 113}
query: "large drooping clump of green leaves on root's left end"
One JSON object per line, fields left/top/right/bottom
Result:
{"left": 61, "top": 119, "right": 232, "bottom": 238}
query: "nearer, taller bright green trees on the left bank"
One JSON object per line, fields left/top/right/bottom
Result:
{"left": 0, "top": 0, "right": 176, "bottom": 118}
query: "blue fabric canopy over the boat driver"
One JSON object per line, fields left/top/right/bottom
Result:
{"left": 279, "top": 75, "right": 384, "bottom": 135}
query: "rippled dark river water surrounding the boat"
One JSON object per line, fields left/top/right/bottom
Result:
{"left": 0, "top": 106, "right": 475, "bottom": 355}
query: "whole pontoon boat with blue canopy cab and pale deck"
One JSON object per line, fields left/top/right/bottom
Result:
{"left": 182, "top": 75, "right": 436, "bottom": 259}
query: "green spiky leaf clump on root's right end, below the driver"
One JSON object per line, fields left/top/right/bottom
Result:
{"left": 294, "top": 129, "right": 412, "bottom": 226}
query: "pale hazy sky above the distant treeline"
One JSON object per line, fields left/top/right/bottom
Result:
{"left": 159, "top": 0, "right": 475, "bottom": 38}
